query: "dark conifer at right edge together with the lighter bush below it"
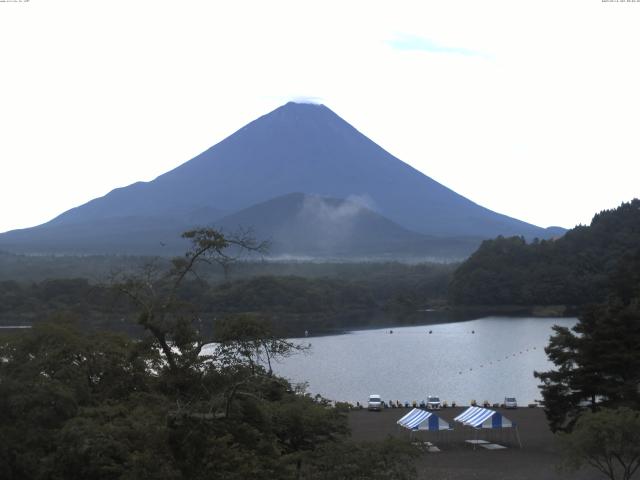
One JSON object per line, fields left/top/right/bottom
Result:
{"left": 534, "top": 227, "right": 640, "bottom": 480}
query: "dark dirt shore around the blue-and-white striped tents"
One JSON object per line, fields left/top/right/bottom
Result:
{"left": 349, "top": 408, "right": 603, "bottom": 480}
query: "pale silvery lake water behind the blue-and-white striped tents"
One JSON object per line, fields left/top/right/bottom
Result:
{"left": 274, "top": 317, "right": 577, "bottom": 405}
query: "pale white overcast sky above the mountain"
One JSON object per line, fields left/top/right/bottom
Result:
{"left": 0, "top": 0, "right": 640, "bottom": 232}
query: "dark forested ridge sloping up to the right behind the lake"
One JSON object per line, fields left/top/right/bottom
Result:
{"left": 449, "top": 199, "right": 640, "bottom": 306}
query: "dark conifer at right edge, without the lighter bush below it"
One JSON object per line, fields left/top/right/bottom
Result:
{"left": 536, "top": 250, "right": 640, "bottom": 430}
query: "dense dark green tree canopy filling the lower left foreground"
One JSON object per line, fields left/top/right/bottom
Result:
{"left": 0, "top": 322, "right": 360, "bottom": 479}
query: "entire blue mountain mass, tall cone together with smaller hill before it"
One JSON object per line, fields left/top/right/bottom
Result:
{"left": 0, "top": 102, "right": 563, "bottom": 257}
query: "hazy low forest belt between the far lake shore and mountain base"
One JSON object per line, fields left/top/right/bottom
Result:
{"left": 0, "top": 256, "right": 455, "bottom": 336}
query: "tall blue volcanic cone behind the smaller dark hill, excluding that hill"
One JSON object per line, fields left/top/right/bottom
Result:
{"left": 0, "top": 102, "right": 560, "bottom": 252}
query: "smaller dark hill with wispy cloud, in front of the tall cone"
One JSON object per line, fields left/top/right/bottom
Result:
{"left": 215, "top": 193, "right": 481, "bottom": 259}
